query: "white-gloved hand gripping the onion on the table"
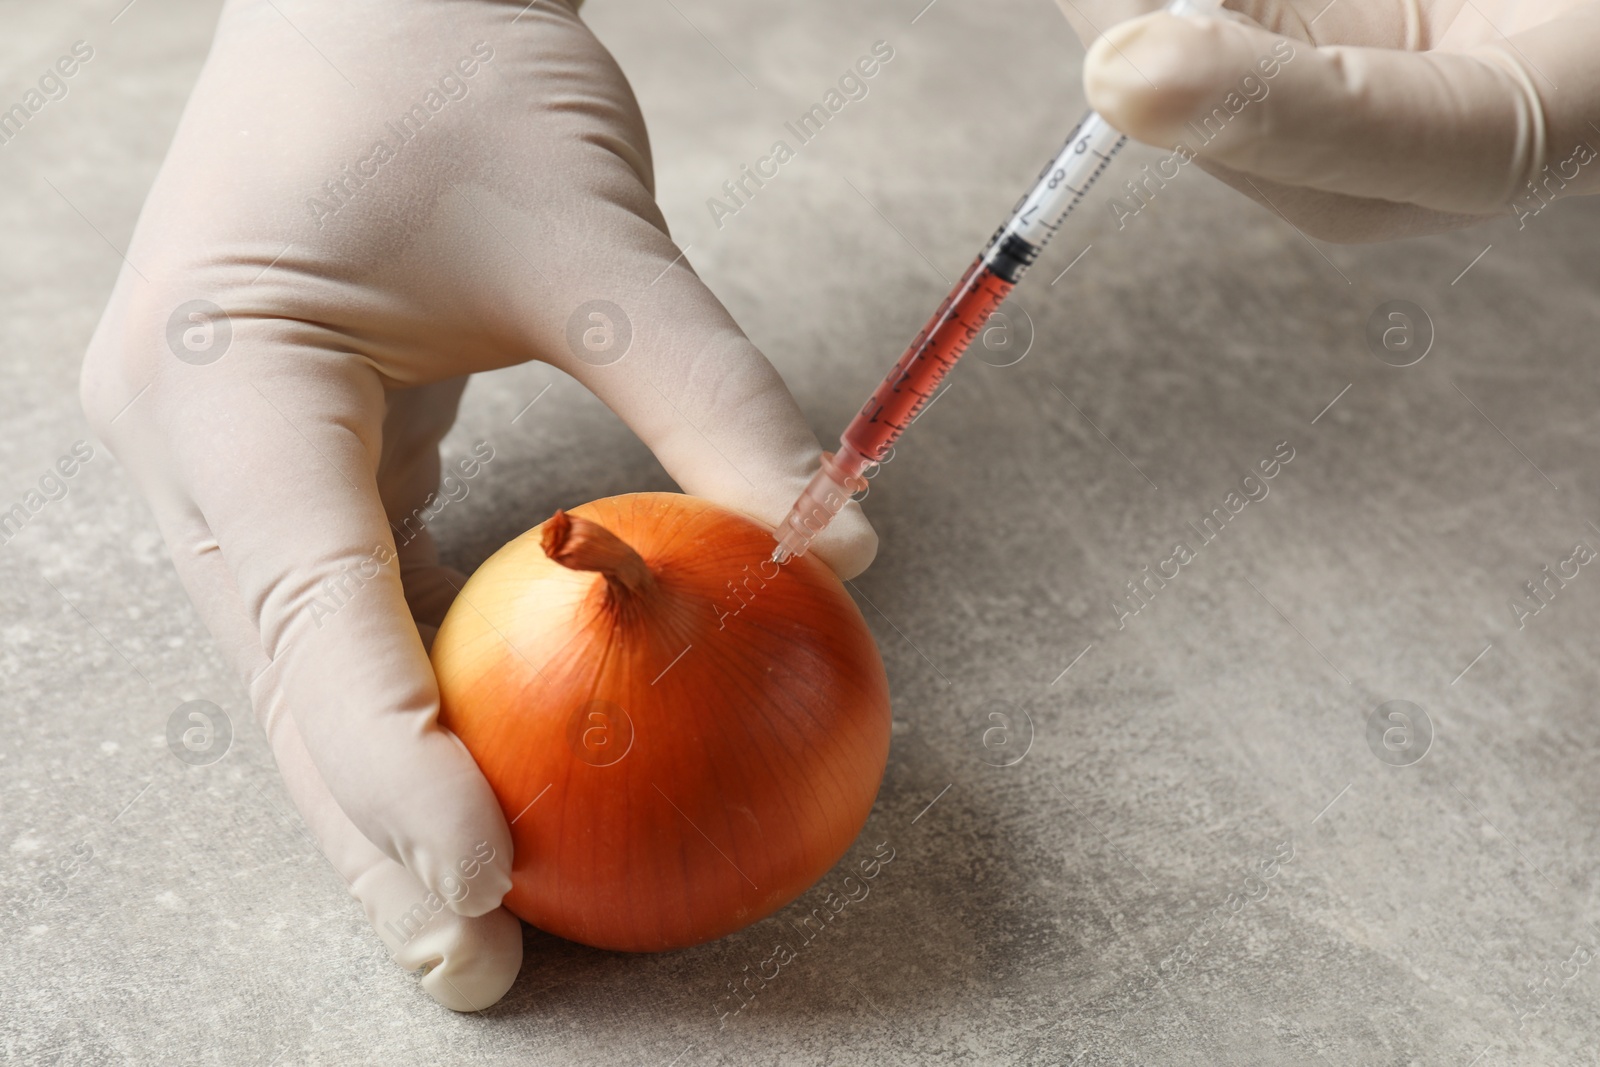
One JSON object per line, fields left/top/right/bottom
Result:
{"left": 82, "top": 0, "right": 875, "bottom": 1011}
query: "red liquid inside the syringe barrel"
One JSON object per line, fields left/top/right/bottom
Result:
{"left": 842, "top": 256, "right": 1016, "bottom": 463}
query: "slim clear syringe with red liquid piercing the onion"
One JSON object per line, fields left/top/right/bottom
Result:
{"left": 773, "top": 0, "right": 1218, "bottom": 563}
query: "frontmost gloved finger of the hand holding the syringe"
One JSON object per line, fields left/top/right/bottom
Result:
{"left": 1085, "top": 14, "right": 1574, "bottom": 223}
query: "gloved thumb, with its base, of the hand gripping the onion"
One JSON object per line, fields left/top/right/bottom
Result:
{"left": 337, "top": 0, "right": 877, "bottom": 575}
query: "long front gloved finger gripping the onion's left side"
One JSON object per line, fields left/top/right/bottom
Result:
{"left": 166, "top": 337, "right": 510, "bottom": 915}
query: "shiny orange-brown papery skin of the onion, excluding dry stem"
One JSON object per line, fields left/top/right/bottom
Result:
{"left": 432, "top": 493, "right": 890, "bottom": 952}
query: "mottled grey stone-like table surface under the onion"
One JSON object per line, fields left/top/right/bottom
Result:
{"left": 0, "top": 0, "right": 1600, "bottom": 1067}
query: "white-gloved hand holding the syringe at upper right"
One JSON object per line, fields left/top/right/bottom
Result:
{"left": 1059, "top": 0, "right": 1600, "bottom": 242}
